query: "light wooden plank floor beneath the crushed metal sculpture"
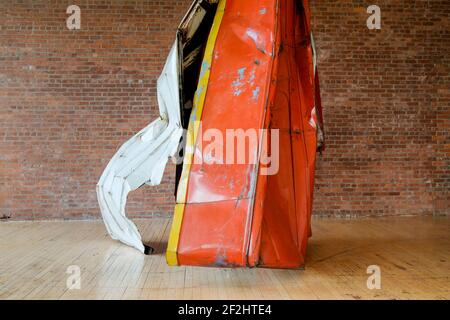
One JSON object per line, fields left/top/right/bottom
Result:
{"left": 0, "top": 217, "right": 450, "bottom": 299}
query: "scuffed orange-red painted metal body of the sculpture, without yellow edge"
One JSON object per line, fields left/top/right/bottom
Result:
{"left": 169, "top": 0, "right": 323, "bottom": 268}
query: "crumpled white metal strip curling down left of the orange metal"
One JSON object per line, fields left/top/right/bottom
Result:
{"left": 97, "top": 41, "right": 183, "bottom": 252}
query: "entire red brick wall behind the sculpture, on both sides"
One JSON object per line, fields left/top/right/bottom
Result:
{"left": 0, "top": 0, "right": 450, "bottom": 219}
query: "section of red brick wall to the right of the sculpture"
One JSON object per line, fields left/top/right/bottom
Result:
{"left": 311, "top": 0, "right": 450, "bottom": 216}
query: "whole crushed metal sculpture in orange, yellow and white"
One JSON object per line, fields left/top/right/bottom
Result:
{"left": 97, "top": 0, "right": 323, "bottom": 268}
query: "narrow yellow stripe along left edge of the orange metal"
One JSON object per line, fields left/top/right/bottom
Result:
{"left": 166, "top": 0, "right": 226, "bottom": 266}
